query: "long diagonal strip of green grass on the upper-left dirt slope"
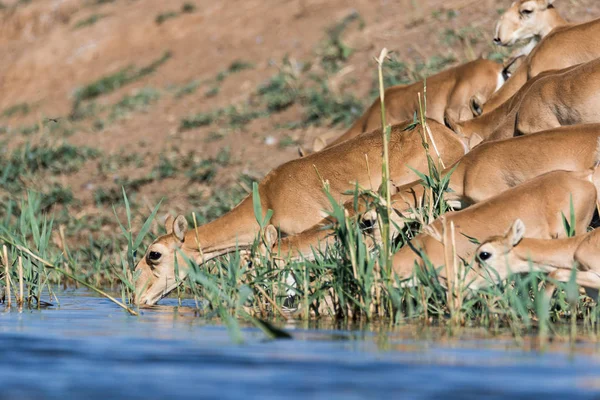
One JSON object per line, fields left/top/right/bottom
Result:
{"left": 72, "top": 52, "right": 171, "bottom": 115}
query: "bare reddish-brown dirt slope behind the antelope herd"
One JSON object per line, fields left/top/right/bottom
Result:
{"left": 0, "top": 0, "right": 600, "bottom": 241}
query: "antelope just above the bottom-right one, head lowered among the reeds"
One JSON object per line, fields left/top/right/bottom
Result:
{"left": 393, "top": 170, "right": 597, "bottom": 282}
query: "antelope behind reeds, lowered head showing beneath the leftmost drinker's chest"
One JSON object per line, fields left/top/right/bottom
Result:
{"left": 275, "top": 124, "right": 600, "bottom": 259}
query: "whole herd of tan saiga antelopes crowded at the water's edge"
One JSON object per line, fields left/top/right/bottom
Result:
{"left": 135, "top": 0, "right": 600, "bottom": 305}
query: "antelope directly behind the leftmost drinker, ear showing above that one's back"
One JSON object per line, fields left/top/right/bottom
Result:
{"left": 313, "top": 59, "right": 503, "bottom": 151}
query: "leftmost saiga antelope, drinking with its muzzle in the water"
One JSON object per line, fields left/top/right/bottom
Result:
{"left": 136, "top": 121, "right": 465, "bottom": 304}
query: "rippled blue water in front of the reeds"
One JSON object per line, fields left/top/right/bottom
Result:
{"left": 0, "top": 292, "right": 600, "bottom": 400}
